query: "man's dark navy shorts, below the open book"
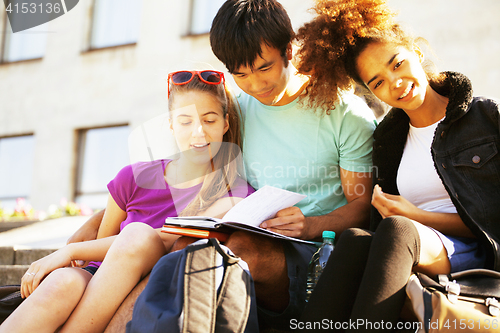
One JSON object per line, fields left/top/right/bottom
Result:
{"left": 257, "top": 241, "right": 317, "bottom": 331}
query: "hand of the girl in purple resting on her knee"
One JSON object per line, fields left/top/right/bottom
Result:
{"left": 21, "top": 246, "right": 72, "bottom": 298}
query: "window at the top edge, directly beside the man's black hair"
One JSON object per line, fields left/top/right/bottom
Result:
{"left": 190, "top": 0, "right": 225, "bottom": 35}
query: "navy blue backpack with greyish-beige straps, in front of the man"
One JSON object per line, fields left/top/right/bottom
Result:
{"left": 126, "top": 238, "right": 259, "bottom": 333}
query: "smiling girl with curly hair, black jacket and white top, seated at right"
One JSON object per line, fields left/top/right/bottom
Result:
{"left": 297, "top": 0, "right": 500, "bottom": 332}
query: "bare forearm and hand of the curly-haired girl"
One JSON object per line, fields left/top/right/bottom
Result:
{"left": 372, "top": 185, "right": 475, "bottom": 237}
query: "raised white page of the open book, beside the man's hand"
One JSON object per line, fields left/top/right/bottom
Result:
{"left": 222, "top": 185, "right": 306, "bottom": 227}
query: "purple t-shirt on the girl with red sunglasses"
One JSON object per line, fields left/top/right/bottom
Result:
{"left": 90, "top": 160, "right": 255, "bottom": 266}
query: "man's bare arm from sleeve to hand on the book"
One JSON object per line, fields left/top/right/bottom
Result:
{"left": 261, "top": 169, "right": 372, "bottom": 240}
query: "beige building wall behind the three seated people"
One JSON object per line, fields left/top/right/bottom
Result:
{"left": 0, "top": 0, "right": 500, "bottom": 209}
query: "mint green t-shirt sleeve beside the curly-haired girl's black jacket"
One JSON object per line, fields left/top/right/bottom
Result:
{"left": 339, "top": 96, "right": 376, "bottom": 172}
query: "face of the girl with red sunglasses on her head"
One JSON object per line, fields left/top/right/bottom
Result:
{"left": 170, "top": 90, "right": 229, "bottom": 163}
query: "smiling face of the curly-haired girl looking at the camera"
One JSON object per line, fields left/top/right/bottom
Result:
{"left": 356, "top": 43, "right": 431, "bottom": 112}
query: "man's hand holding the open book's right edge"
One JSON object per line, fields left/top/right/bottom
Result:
{"left": 260, "top": 206, "right": 308, "bottom": 239}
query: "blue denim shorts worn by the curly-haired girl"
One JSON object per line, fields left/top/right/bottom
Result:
{"left": 432, "top": 229, "right": 486, "bottom": 273}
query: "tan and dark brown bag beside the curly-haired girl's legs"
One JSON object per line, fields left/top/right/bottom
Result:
{"left": 406, "top": 269, "right": 500, "bottom": 333}
